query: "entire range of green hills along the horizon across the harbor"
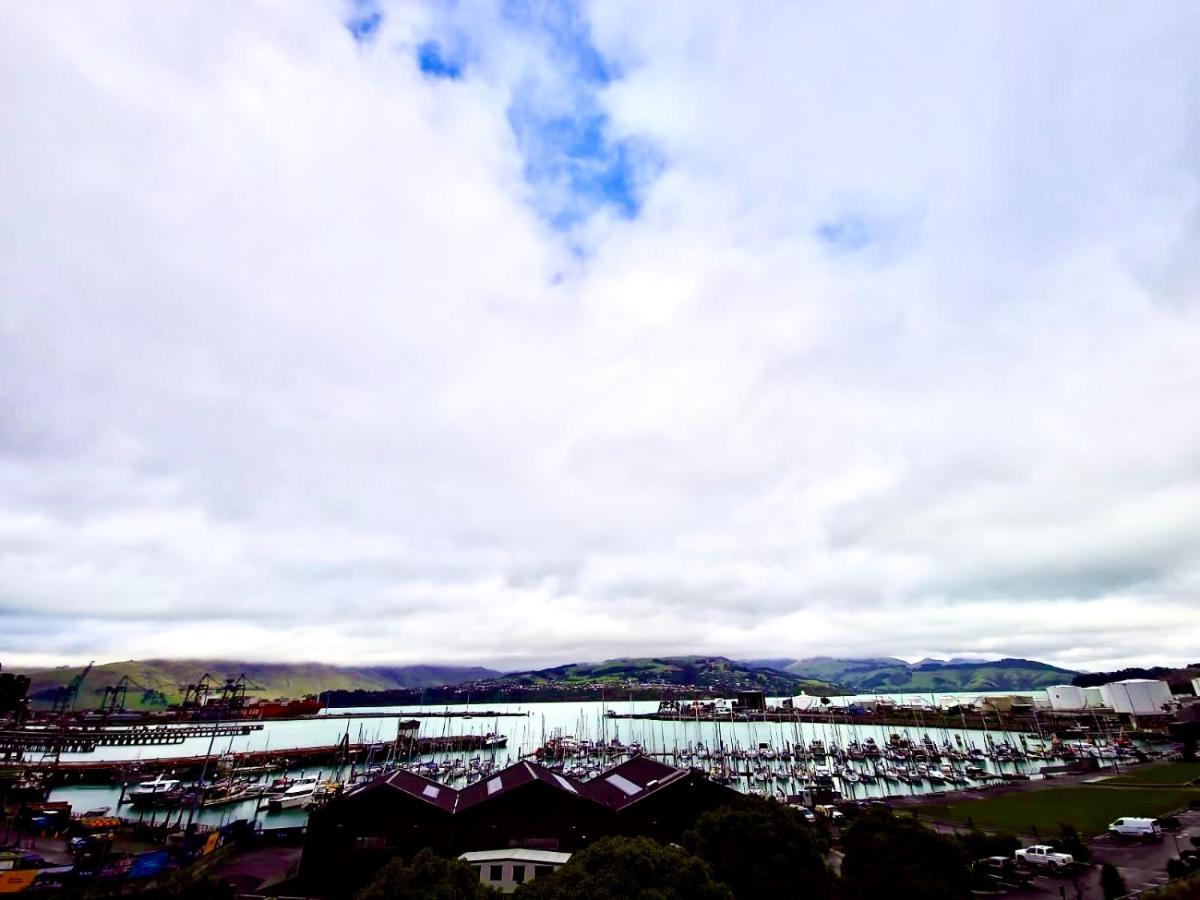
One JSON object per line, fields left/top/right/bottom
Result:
{"left": 14, "top": 656, "right": 1094, "bottom": 709}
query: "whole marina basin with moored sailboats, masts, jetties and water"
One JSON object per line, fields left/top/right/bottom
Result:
{"left": 25, "top": 698, "right": 1171, "bottom": 824}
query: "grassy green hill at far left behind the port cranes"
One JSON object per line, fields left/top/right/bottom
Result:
{"left": 11, "top": 660, "right": 499, "bottom": 709}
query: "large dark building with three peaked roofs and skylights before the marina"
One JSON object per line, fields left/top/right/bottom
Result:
{"left": 300, "top": 756, "right": 743, "bottom": 896}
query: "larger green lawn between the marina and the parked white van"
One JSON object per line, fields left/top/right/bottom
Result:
{"left": 917, "top": 785, "right": 1200, "bottom": 838}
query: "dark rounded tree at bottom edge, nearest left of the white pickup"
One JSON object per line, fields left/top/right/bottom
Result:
{"left": 841, "top": 809, "right": 971, "bottom": 900}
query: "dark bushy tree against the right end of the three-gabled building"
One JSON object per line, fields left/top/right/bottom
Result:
{"left": 684, "top": 797, "right": 830, "bottom": 900}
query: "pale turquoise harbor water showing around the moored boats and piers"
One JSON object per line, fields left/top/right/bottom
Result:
{"left": 52, "top": 695, "right": 1113, "bottom": 827}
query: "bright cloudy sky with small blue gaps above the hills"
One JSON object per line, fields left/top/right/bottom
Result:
{"left": 0, "top": 0, "right": 1200, "bottom": 670}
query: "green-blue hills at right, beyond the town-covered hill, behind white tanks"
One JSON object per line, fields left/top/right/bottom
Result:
{"left": 746, "top": 656, "right": 1079, "bottom": 694}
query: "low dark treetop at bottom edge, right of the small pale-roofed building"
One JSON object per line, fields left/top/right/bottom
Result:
{"left": 516, "top": 838, "right": 733, "bottom": 900}
